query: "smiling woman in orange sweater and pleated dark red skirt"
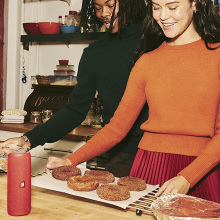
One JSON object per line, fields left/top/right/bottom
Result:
{"left": 47, "top": 0, "right": 220, "bottom": 203}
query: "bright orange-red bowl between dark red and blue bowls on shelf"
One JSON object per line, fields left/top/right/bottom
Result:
{"left": 39, "top": 22, "right": 62, "bottom": 34}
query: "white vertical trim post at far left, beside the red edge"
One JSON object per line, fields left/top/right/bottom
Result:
{"left": 4, "top": 0, "right": 21, "bottom": 108}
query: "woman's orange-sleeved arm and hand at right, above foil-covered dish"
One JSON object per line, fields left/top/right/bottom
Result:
{"left": 156, "top": 100, "right": 220, "bottom": 196}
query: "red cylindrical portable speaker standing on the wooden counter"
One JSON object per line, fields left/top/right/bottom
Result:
{"left": 7, "top": 152, "right": 31, "bottom": 216}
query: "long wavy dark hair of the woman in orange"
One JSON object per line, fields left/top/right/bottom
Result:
{"left": 132, "top": 0, "right": 220, "bottom": 65}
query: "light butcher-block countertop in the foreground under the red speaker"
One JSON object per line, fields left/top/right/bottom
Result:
{"left": 0, "top": 173, "right": 156, "bottom": 220}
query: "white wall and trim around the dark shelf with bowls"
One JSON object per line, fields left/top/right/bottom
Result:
{"left": 4, "top": 0, "right": 90, "bottom": 109}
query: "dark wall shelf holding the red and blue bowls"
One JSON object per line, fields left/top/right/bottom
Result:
{"left": 21, "top": 32, "right": 104, "bottom": 50}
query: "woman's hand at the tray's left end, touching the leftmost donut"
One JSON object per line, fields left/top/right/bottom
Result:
{"left": 45, "top": 157, "right": 72, "bottom": 174}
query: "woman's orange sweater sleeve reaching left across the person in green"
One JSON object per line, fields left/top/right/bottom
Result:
{"left": 67, "top": 58, "right": 146, "bottom": 165}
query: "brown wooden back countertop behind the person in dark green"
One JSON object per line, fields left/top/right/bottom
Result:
{"left": 0, "top": 122, "right": 100, "bottom": 141}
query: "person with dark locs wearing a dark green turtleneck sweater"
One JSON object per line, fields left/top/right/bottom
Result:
{"left": 0, "top": 0, "right": 148, "bottom": 177}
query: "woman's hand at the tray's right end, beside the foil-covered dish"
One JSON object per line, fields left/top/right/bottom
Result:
{"left": 156, "top": 176, "right": 190, "bottom": 196}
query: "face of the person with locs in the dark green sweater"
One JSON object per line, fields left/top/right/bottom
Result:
{"left": 93, "top": 0, "right": 119, "bottom": 33}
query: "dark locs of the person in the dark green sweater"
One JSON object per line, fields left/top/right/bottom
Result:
{"left": 81, "top": 0, "right": 147, "bottom": 31}
